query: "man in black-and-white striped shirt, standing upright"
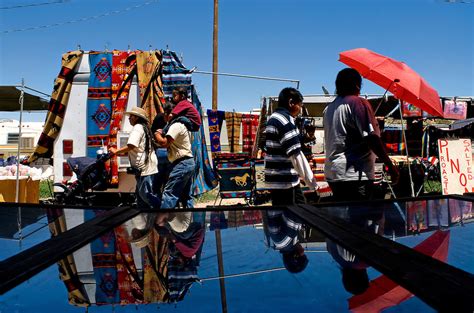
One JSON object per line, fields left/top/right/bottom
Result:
{"left": 265, "top": 88, "right": 318, "bottom": 205}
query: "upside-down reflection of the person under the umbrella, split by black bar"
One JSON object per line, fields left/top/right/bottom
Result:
{"left": 326, "top": 207, "right": 385, "bottom": 295}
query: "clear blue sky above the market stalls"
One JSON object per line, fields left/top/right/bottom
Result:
{"left": 0, "top": 0, "right": 474, "bottom": 121}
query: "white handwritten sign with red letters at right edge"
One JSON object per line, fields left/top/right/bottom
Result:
{"left": 438, "top": 139, "right": 474, "bottom": 195}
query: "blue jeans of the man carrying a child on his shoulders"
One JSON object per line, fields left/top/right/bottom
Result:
{"left": 161, "top": 158, "right": 196, "bottom": 209}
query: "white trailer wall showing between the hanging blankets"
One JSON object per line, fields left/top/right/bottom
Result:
{"left": 53, "top": 52, "right": 139, "bottom": 192}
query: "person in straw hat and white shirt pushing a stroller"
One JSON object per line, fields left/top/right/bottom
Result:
{"left": 109, "top": 107, "right": 161, "bottom": 239}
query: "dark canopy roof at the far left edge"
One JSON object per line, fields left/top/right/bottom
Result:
{"left": 0, "top": 86, "right": 49, "bottom": 111}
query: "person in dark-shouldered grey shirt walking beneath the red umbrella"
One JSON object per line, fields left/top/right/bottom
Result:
{"left": 324, "top": 68, "right": 399, "bottom": 201}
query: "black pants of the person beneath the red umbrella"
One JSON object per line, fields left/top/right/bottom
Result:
{"left": 328, "top": 180, "right": 374, "bottom": 201}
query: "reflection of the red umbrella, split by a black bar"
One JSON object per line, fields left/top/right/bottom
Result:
{"left": 349, "top": 230, "right": 449, "bottom": 313}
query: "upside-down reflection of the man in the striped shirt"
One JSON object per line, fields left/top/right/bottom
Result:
{"left": 266, "top": 210, "right": 308, "bottom": 273}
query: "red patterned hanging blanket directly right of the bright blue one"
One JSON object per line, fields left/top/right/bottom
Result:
{"left": 108, "top": 50, "right": 136, "bottom": 187}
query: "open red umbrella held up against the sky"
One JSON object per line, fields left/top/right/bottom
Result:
{"left": 339, "top": 48, "right": 443, "bottom": 116}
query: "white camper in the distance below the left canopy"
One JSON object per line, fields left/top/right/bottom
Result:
{"left": 0, "top": 119, "right": 44, "bottom": 159}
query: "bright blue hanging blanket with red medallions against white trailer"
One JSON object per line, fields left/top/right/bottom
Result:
{"left": 87, "top": 52, "right": 112, "bottom": 158}
